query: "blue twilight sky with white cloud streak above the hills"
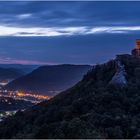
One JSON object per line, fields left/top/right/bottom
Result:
{"left": 0, "top": 1, "right": 140, "bottom": 64}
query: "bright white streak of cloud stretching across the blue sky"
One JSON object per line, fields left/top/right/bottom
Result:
{"left": 0, "top": 26, "right": 140, "bottom": 37}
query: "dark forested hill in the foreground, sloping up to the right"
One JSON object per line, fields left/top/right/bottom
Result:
{"left": 0, "top": 55, "right": 140, "bottom": 139}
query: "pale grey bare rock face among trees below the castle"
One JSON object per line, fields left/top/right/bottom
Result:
{"left": 110, "top": 61, "right": 127, "bottom": 86}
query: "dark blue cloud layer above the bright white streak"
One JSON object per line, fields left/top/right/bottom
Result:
{"left": 0, "top": 1, "right": 140, "bottom": 26}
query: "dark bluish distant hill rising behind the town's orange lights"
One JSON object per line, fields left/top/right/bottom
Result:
{"left": 5, "top": 65, "right": 91, "bottom": 95}
